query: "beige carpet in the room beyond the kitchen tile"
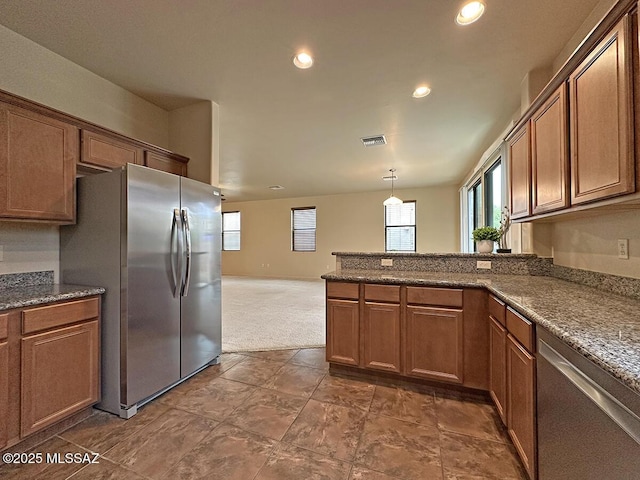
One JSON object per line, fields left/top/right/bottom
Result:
{"left": 222, "top": 275, "right": 325, "bottom": 352}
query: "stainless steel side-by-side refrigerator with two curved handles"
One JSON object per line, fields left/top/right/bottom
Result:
{"left": 60, "top": 164, "right": 221, "bottom": 418}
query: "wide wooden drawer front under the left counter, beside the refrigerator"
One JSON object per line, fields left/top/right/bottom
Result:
{"left": 22, "top": 297, "right": 100, "bottom": 335}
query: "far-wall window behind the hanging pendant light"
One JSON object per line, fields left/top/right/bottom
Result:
{"left": 384, "top": 200, "right": 416, "bottom": 252}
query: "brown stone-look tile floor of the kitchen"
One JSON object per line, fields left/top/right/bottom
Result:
{"left": 0, "top": 348, "right": 526, "bottom": 480}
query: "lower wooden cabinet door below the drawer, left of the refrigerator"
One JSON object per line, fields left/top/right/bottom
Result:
{"left": 20, "top": 320, "right": 100, "bottom": 437}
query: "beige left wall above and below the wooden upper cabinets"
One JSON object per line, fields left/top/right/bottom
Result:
{"left": 0, "top": 25, "right": 169, "bottom": 280}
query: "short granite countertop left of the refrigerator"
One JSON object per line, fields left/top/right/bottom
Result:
{"left": 0, "top": 283, "right": 104, "bottom": 311}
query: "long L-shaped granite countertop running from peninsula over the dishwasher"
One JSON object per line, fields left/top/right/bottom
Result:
{"left": 322, "top": 270, "right": 640, "bottom": 393}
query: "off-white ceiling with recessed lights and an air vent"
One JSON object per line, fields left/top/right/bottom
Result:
{"left": 0, "top": 0, "right": 598, "bottom": 200}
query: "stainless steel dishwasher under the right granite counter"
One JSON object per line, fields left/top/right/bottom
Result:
{"left": 537, "top": 328, "right": 640, "bottom": 480}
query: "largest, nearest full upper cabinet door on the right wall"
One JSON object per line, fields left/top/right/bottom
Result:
{"left": 569, "top": 16, "right": 635, "bottom": 204}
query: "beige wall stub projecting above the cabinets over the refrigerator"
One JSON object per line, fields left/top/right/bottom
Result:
{"left": 169, "top": 101, "right": 219, "bottom": 185}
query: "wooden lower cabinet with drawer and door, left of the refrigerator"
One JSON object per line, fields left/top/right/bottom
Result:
{"left": 0, "top": 296, "right": 100, "bottom": 450}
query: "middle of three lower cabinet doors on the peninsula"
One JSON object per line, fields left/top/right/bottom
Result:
{"left": 362, "top": 302, "right": 400, "bottom": 373}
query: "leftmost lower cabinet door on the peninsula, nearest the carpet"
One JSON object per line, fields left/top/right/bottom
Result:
{"left": 327, "top": 299, "right": 360, "bottom": 365}
